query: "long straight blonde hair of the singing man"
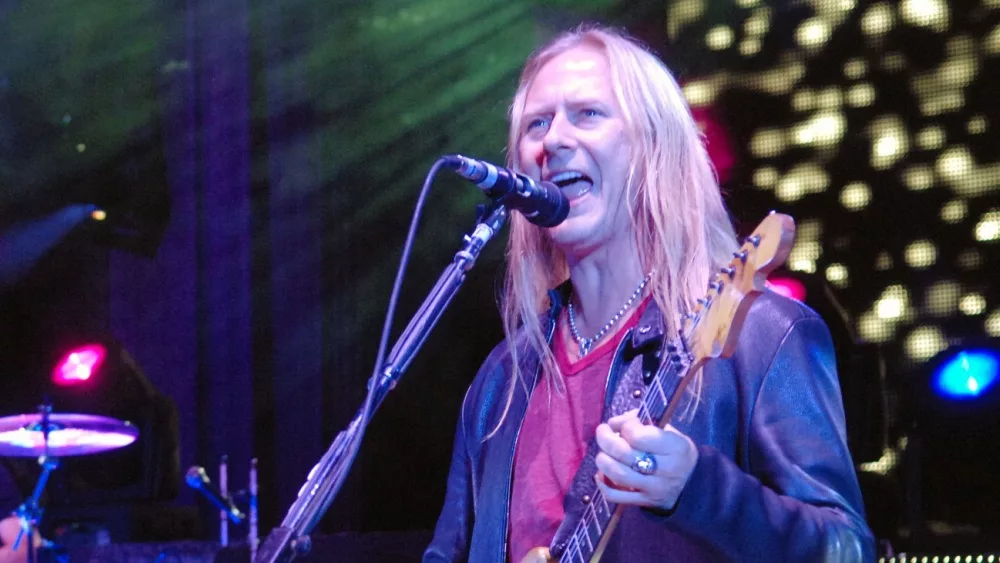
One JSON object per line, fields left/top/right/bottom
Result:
{"left": 492, "top": 22, "right": 738, "bottom": 428}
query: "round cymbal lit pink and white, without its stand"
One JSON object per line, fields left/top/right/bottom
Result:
{"left": 0, "top": 413, "right": 139, "bottom": 457}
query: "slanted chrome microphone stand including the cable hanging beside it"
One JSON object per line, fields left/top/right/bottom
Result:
{"left": 254, "top": 157, "right": 516, "bottom": 563}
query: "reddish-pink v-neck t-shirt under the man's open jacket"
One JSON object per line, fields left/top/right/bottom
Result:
{"left": 509, "top": 301, "right": 646, "bottom": 563}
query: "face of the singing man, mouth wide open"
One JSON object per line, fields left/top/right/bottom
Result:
{"left": 517, "top": 45, "right": 630, "bottom": 259}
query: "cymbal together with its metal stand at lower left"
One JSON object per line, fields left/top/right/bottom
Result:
{"left": 0, "top": 405, "right": 139, "bottom": 563}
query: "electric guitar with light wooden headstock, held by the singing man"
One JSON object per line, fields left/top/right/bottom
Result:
{"left": 521, "top": 212, "right": 795, "bottom": 563}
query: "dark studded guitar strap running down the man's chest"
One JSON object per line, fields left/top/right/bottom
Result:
{"left": 549, "top": 301, "right": 665, "bottom": 559}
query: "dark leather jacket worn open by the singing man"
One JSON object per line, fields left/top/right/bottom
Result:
{"left": 423, "top": 292, "right": 875, "bottom": 563}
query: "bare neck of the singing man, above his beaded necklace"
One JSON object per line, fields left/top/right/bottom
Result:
{"left": 569, "top": 232, "right": 648, "bottom": 337}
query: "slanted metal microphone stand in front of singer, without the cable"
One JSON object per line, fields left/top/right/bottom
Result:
{"left": 254, "top": 202, "right": 508, "bottom": 563}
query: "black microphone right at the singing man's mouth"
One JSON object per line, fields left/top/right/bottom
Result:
{"left": 444, "top": 154, "right": 569, "bottom": 227}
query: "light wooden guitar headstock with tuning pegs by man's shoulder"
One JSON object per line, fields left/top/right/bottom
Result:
{"left": 682, "top": 211, "right": 795, "bottom": 363}
